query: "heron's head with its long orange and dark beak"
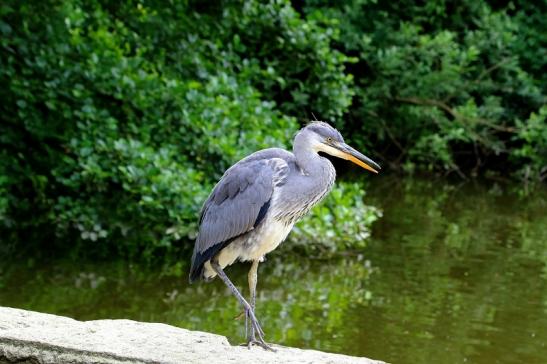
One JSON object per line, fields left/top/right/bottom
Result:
{"left": 302, "top": 121, "right": 381, "bottom": 173}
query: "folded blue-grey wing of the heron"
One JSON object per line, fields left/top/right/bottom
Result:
{"left": 190, "top": 158, "right": 289, "bottom": 282}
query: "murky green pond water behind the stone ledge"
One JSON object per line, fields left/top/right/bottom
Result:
{"left": 0, "top": 178, "right": 547, "bottom": 364}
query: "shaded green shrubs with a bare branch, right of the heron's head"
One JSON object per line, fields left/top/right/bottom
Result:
{"left": 305, "top": 0, "right": 547, "bottom": 180}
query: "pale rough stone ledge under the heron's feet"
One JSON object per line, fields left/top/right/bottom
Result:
{"left": 0, "top": 307, "right": 382, "bottom": 364}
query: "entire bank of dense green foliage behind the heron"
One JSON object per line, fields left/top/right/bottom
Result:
{"left": 0, "top": 0, "right": 547, "bottom": 257}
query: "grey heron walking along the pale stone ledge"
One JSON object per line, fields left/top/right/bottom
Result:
{"left": 190, "top": 121, "right": 380, "bottom": 349}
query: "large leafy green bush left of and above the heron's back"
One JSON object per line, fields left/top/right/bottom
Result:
{"left": 0, "top": 0, "right": 372, "bottom": 258}
